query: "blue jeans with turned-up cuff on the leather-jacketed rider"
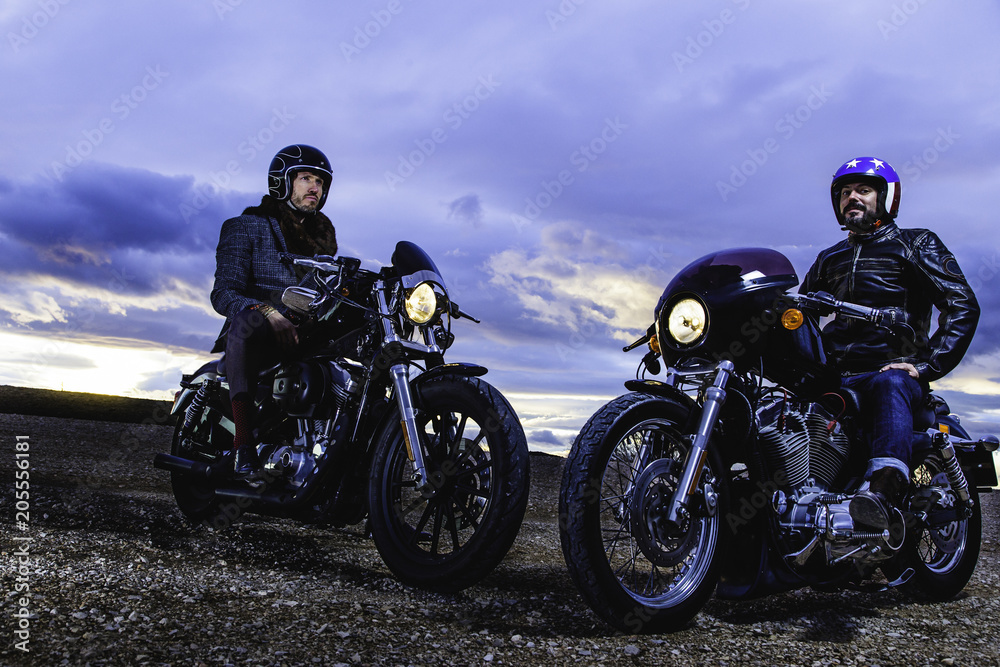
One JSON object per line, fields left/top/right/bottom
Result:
{"left": 842, "top": 368, "right": 926, "bottom": 479}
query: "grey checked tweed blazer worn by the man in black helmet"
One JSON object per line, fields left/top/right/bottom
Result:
{"left": 211, "top": 214, "right": 299, "bottom": 348}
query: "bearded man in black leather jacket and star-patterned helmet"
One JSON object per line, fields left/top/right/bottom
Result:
{"left": 799, "top": 157, "right": 979, "bottom": 530}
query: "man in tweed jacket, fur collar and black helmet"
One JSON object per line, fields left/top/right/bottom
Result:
{"left": 211, "top": 144, "right": 337, "bottom": 484}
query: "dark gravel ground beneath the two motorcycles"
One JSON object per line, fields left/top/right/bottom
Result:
{"left": 0, "top": 415, "right": 1000, "bottom": 667}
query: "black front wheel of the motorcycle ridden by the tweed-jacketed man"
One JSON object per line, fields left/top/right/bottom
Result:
{"left": 368, "top": 376, "right": 528, "bottom": 592}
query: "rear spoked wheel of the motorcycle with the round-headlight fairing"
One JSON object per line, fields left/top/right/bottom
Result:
{"left": 886, "top": 454, "right": 983, "bottom": 600}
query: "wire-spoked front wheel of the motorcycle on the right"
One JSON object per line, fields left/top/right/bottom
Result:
{"left": 559, "top": 393, "right": 729, "bottom": 634}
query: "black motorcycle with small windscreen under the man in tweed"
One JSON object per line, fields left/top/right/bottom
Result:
{"left": 154, "top": 241, "right": 528, "bottom": 592}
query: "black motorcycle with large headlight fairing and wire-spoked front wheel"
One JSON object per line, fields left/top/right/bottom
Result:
{"left": 560, "top": 248, "right": 998, "bottom": 634}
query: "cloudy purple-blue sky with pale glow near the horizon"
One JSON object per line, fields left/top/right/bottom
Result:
{"left": 0, "top": 0, "right": 1000, "bottom": 453}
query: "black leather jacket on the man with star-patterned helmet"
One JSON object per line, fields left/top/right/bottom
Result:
{"left": 799, "top": 222, "right": 979, "bottom": 382}
